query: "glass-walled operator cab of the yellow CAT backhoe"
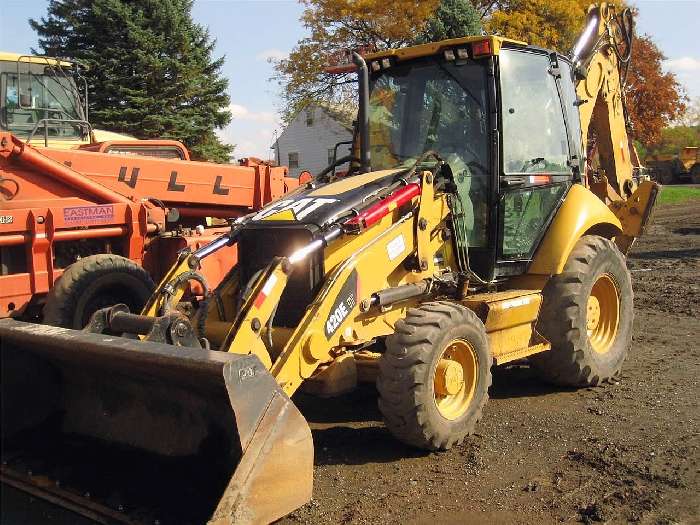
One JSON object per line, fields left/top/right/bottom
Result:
{"left": 358, "top": 37, "right": 583, "bottom": 281}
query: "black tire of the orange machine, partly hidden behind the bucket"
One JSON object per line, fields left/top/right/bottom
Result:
{"left": 43, "top": 254, "right": 154, "bottom": 330}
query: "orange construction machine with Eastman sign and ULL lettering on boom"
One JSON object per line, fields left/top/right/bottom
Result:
{"left": 0, "top": 132, "right": 298, "bottom": 328}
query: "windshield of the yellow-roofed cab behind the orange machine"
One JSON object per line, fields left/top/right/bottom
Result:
{"left": 0, "top": 62, "right": 85, "bottom": 139}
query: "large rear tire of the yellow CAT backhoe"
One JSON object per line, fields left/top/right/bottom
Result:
{"left": 530, "top": 235, "right": 634, "bottom": 386}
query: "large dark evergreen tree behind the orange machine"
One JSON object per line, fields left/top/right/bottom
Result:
{"left": 29, "top": 0, "right": 233, "bottom": 162}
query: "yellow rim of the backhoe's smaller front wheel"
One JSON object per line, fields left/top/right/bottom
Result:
{"left": 433, "top": 339, "right": 479, "bottom": 420}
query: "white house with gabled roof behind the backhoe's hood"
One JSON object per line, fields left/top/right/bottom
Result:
{"left": 272, "top": 105, "right": 352, "bottom": 177}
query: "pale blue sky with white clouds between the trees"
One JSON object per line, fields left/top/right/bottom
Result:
{"left": 0, "top": 0, "right": 700, "bottom": 157}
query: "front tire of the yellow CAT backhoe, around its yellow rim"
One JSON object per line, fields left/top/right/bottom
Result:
{"left": 377, "top": 302, "right": 493, "bottom": 450}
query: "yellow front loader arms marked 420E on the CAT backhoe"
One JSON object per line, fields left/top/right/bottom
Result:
{"left": 222, "top": 172, "right": 448, "bottom": 396}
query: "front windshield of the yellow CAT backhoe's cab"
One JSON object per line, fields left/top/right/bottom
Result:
{"left": 369, "top": 58, "right": 488, "bottom": 174}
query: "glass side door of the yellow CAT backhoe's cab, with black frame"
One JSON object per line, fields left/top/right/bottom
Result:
{"left": 494, "top": 49, "right": 582, "bottom": 277}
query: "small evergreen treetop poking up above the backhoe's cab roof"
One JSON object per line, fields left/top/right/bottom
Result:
{"left": 416, "top": 0, "right": 482, "bottom": 44}
